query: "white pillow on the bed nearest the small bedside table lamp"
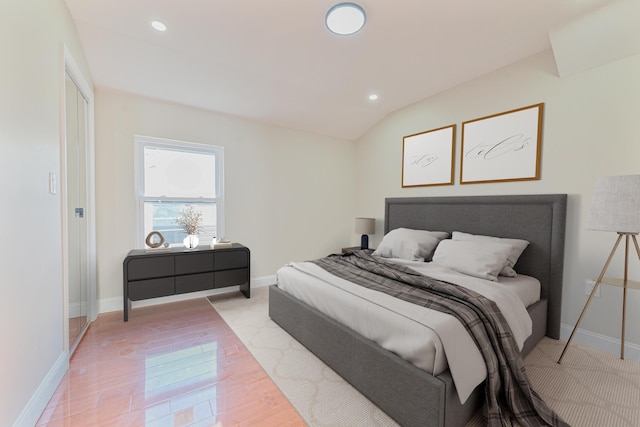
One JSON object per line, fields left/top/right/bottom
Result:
{"left": 373, "top": 228, "right": 449, "bottom": 261}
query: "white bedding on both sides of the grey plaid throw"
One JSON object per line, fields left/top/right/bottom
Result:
{"left": 277, "top": 259, "right": 540, "bottom": 402}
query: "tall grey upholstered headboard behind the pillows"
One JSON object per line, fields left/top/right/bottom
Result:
{"left": 384, "top": 194, "right": 567, "bottom": 339}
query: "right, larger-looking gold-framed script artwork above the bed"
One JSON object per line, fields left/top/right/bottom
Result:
{"left": 460, "top": 104, "right": 544, "bottom": 184}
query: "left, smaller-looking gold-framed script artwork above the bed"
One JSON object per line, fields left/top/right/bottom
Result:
{"left": 402, "top": 125, "right": 456, "bottom": 188}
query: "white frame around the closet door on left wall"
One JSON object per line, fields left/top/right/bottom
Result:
{"left": 60, "top": 44, "right": 98, "bottom": 356}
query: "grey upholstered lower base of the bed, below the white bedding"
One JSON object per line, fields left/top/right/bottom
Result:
{"left": 269, "top": 285, "right": 484, "bottom": 426}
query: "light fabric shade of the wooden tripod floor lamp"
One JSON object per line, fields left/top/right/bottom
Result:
{"left": 587, "top": 175, "right": 640, "bottom": 233}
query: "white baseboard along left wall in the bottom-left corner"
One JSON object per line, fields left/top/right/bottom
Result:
{"left": 13, "top": 351, "right": 69, "bottom": 427}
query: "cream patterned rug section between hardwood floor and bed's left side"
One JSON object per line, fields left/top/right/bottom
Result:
{"left": 209, "top": 287, "right": 398, "bottom": 426}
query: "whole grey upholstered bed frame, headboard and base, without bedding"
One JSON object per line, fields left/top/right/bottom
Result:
{"left": 269, "top": 194, "right": 567, "bottom": 426}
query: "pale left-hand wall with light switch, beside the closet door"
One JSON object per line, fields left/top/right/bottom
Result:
{"left": 0, "top": 0, "right": 90, "bottom": 426}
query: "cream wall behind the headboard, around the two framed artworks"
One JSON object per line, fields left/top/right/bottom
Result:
{"left": 356, "top": 47, "right": 640, "bottom": 354}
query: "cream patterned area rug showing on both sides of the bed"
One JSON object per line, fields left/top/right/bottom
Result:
{"left": 209, "top": 287, "right": 640, "bottom": 427}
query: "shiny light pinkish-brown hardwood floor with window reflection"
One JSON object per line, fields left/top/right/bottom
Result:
{"left": 37, "top": 298, "right": 305, "bottom": 427}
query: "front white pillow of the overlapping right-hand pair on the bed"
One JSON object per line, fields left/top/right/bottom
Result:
{"left": 433, "top": 239, "right": 512, "bottom": 282}
